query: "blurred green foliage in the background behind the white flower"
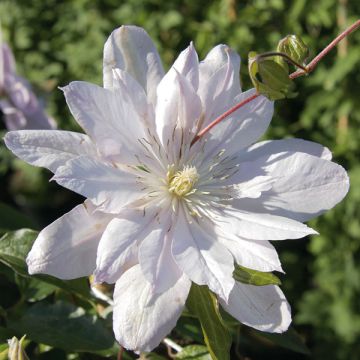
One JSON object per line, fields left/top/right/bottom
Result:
{"left": 0, "top": 0, "right": 360, "bottom": 360}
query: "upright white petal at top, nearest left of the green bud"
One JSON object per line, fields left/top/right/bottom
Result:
{"left": 198, "top": 45, "right": 241, "bottom": 127}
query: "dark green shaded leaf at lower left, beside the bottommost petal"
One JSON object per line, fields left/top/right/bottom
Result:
{"left": 8, "top": 301, "right": 113, "bottom": 352}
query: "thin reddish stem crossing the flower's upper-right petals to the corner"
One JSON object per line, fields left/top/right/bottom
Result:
{"left": 191, "top": 20, "right": 360, "bottom": 145}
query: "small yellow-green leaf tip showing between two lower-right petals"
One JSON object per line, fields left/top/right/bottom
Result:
{"left": 233, "top": 264, "right": 281, "bottom": 286}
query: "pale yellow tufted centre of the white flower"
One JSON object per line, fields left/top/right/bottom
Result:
{"left": 167, "top": 166, "right": 199, "bottom": 197}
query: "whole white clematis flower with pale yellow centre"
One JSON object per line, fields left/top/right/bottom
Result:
{"left": 5, "top": 26, "right": 349, "bottom": 351}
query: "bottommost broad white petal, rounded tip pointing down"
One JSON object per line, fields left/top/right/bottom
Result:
{"left": 113, "top": 265, "right": 191, "bottom": 352}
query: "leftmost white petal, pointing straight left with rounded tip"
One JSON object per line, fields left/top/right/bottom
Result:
{"left": 4, "top": 130, "right": 97, "bottom": 172}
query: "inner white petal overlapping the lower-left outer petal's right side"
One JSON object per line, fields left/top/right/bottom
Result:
{"left": 95, "top": 210, "right": 152, "bottom": 283}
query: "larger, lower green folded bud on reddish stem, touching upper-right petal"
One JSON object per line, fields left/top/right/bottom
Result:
{"left": 249, "top": 52, "right": 296, "bottom": 100}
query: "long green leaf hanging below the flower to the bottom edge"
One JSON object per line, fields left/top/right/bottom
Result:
{"left": 186, "top": 283, "right": 231, "bottom": 360}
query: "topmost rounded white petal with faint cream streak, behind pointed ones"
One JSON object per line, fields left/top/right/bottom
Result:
{"left": 103, "top": 26, "right": 164, "bottom": 105}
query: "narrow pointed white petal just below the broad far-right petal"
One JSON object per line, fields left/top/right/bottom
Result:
{"left": 212, "top": 207, "right": 317, "bottom": 240}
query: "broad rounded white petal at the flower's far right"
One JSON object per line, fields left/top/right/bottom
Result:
{"left": 234, "top": 152, "right": 349, "bottom": 221}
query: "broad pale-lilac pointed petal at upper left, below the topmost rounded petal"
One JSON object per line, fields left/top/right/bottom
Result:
{"left": 62, "top": 81, "right": 146, "bottom": 164}
